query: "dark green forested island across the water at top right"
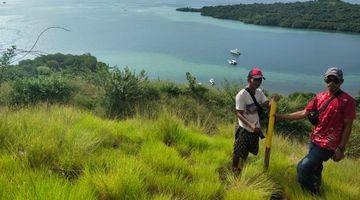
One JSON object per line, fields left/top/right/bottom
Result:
{"left": 177, "top": 0, "right": 360, "bottom": 33}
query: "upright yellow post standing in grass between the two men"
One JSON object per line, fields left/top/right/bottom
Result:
{"left": 264, "top": 100, "right": 277, "bottom": 170}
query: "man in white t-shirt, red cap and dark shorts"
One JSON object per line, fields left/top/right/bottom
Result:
{"left": 232, "top": 67, "right": 269, "bottom": 175}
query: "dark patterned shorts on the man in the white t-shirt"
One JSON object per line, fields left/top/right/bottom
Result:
{"left": 234, "top": 125, "right": 259, "bottom": 159}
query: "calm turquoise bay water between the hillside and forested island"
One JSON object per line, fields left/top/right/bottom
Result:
{"left": 0, "top": 0, "right": 360, "bottom": 95}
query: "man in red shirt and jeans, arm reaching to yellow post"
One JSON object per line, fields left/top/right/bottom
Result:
{"left": 276, "top": 67, "right": 356, "bottom": 194}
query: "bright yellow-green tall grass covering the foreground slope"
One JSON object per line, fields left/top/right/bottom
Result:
{"left": 0, "top": 106, "right": 360, "bottom": 199}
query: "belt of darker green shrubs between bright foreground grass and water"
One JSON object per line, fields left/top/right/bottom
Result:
{"left": 0, "top": 52, "right": 360, "bottom": 157}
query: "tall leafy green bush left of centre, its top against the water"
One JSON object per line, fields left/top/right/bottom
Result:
{"left": 105, "top": 67, "right": 159, "bottom": 118}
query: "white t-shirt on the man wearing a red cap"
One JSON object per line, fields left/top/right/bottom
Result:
{"left": 235, "top": 88, "right": 266, "bottom": 132}
